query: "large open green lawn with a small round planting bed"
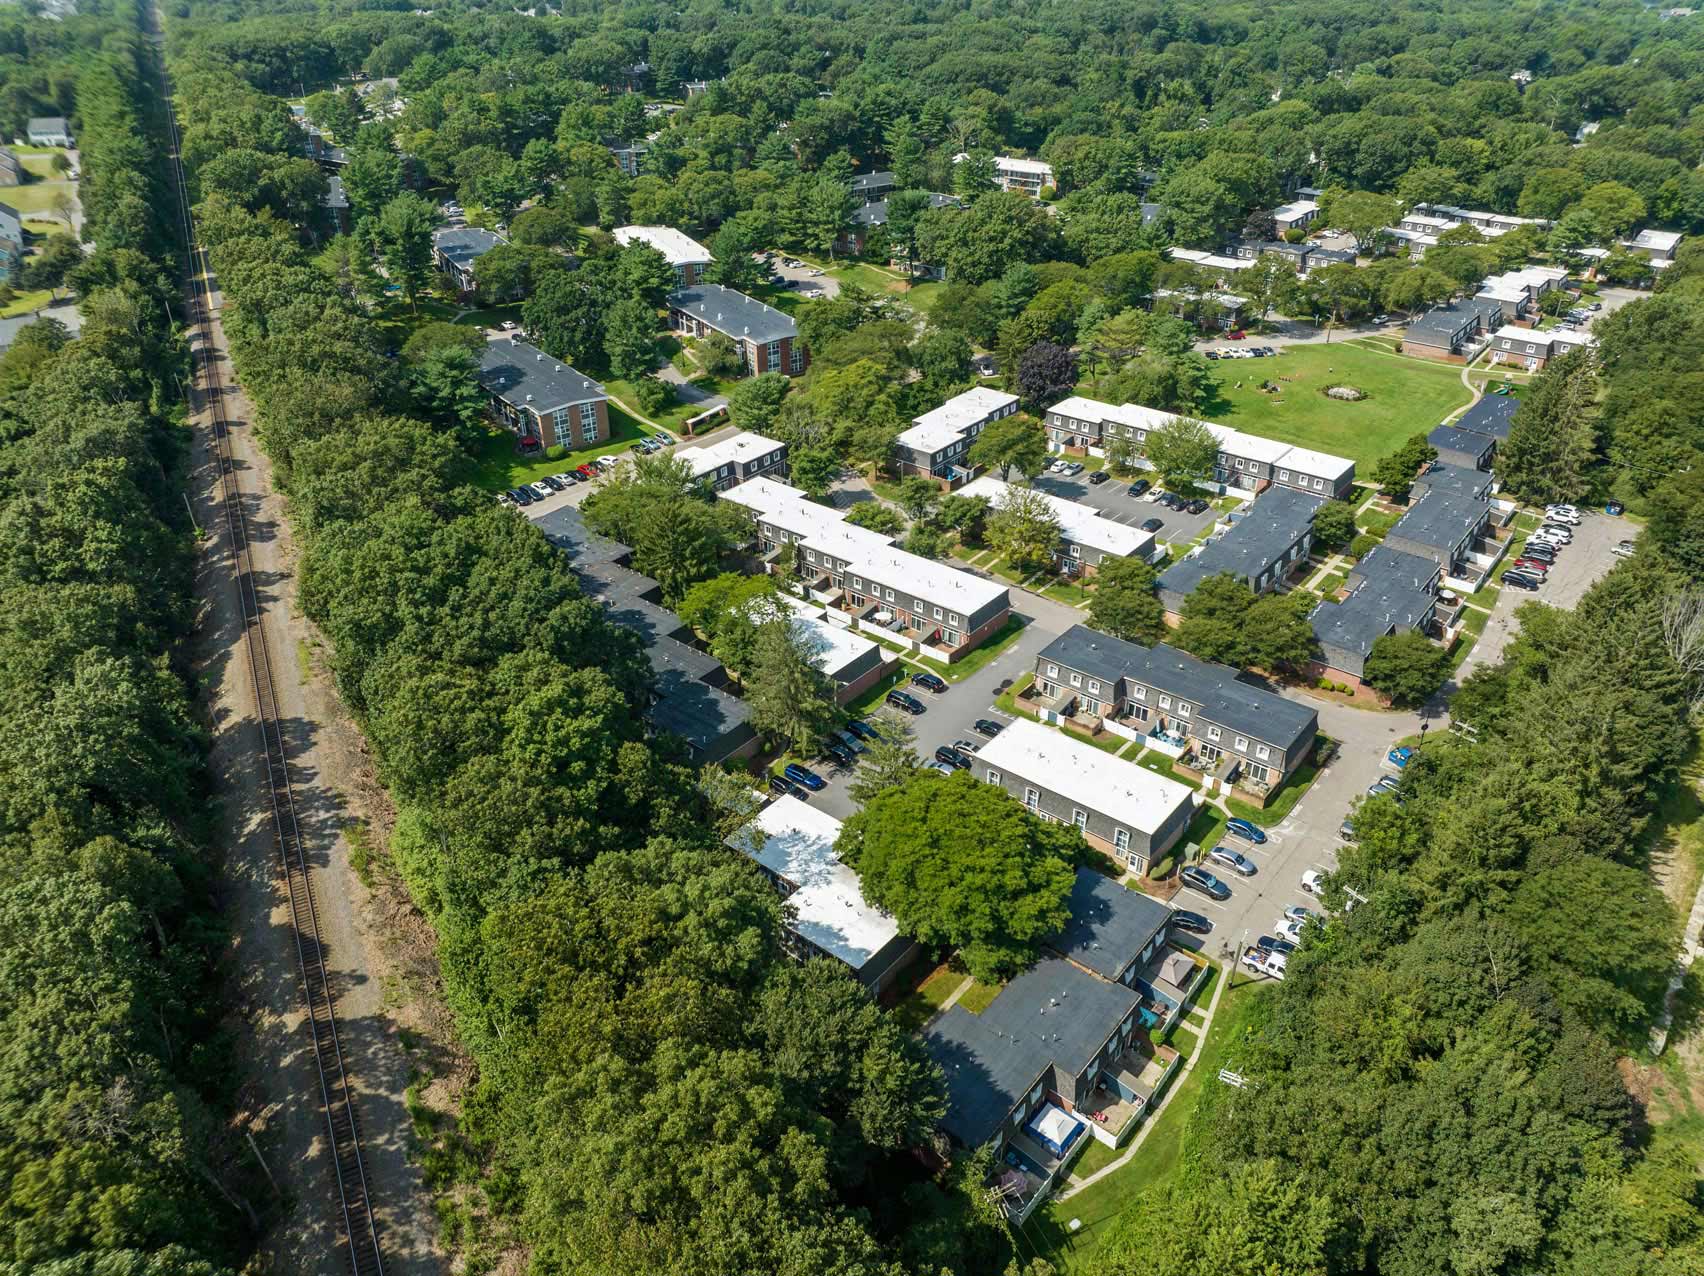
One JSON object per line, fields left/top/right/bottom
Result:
{"left": 1201, "top": 342, "right": 1467, "bottom": 470}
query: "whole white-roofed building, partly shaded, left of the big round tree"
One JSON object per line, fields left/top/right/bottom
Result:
{"left": 728, "top": 797, "right": 918, "bottom": 993}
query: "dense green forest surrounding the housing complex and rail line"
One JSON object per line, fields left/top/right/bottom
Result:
{"left": 0, "top": 0, "right": 1704, "bottom": 1276}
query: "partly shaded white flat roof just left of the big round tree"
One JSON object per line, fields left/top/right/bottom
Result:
{"left": 731, "top": 797, "right": 900, "bottom": 971}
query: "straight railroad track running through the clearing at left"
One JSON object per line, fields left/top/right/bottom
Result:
{"left": 156, "top": 62, "right": 385, "bottom": 1276}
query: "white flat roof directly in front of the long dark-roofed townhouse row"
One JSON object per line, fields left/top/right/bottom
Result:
{"left": 971, "top": 717, "right": 1195, "bottom": 835}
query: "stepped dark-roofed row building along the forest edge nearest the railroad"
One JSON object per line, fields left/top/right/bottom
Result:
{"left": 533, "top": 506, "right": 758, "bottom": 767}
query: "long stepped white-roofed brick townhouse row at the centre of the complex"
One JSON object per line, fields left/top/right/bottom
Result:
{"left": 721, "top": 479, "right": 1012, "bottom": 661}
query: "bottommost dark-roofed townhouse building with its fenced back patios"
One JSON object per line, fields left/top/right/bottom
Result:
{"left": 922, "top": 872, "right": 1206, "bottom": 1221}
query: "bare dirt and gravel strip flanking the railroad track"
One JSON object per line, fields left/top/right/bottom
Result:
{"left": 189, "top": 264, "right": 457, "bottom": 1276}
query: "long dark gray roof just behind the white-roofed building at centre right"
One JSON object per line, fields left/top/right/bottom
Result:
{"left": 1038, "top": 625, "right": 1319, "bottom": 751}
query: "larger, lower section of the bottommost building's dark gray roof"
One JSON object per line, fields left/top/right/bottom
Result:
{"left": 924, "top": 957, "right": 1140, "bottom": 1148}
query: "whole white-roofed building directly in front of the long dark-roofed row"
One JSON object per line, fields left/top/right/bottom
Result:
{"left": 973, "top": 717, "right": 1196, "bottom": 872}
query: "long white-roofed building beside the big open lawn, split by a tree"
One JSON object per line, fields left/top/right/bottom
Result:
{"left": 1045, "top": 395, "right": 1355, "bottom": 499}
